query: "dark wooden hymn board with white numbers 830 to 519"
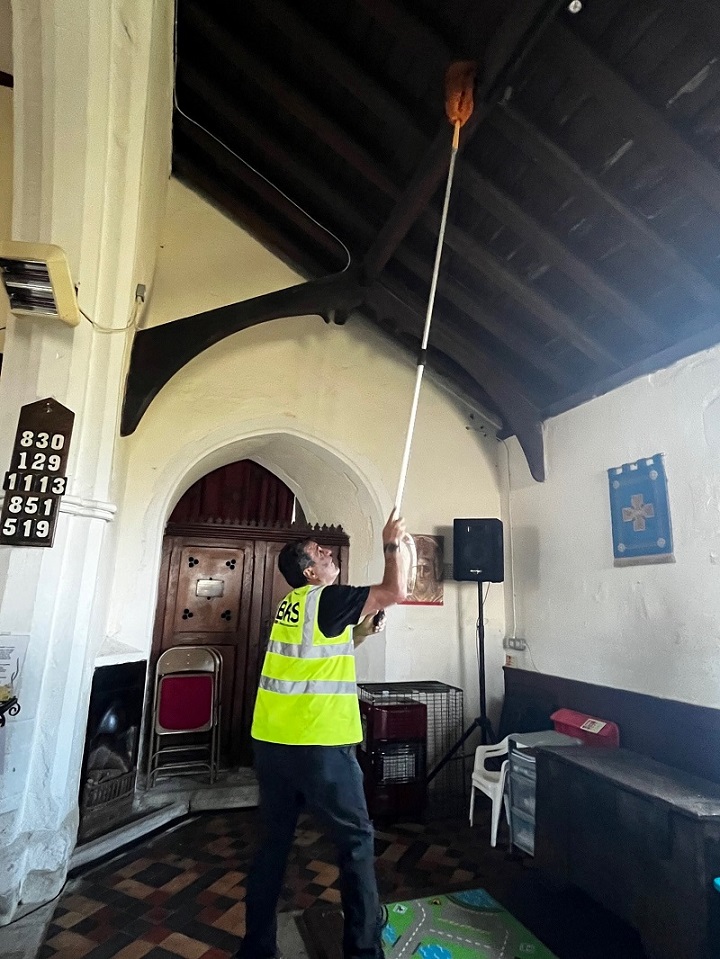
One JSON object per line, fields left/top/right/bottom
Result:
{"left": 0, "top": 398, "right": 75, "bottom": 546}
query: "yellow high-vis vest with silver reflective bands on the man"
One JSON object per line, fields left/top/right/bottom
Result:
{"left": 251, "top": 586, "right": 362, "bottom": 746}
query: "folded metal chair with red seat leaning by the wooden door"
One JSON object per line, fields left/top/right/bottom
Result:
{"left": 148, "top": 646, "right": 222, "bottom": 787}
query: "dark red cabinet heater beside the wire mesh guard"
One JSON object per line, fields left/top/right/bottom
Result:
{"left": 358, "top": 699, "right": 427, "bottom": 816}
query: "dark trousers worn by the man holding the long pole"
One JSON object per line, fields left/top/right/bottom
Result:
{"left": 238, "top": 741, "right": 383, "bottom": 959}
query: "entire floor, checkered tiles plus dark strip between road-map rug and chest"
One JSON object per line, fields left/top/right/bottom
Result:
{"left": 39, "top": 804, "right": 644, "bottom": 959}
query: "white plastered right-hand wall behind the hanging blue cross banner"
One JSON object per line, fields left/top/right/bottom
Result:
{"left": 510, "top": 349, "right": 720, "bottom": 707}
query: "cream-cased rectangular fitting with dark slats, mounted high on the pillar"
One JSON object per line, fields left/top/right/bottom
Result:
{"left": 0, "top": 240, "right": 80, "bottom": 326}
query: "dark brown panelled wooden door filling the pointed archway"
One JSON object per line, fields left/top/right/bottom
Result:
{"left": 151, "top": 459, "right": 349, "bottom": 769}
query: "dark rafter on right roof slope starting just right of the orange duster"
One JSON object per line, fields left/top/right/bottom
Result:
{"left": 490, "top": 103, "right": 720, "bottom": 310}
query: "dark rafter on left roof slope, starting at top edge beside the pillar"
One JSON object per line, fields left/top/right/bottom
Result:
{"left": 180, "top": 0, "right": 400, "bottom": 198}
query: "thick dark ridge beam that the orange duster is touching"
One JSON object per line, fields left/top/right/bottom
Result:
{"left": 363, "top": 0, "right": 565, "bottom": 277}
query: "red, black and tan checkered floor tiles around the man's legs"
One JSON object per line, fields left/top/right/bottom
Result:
{"left": 39, "top": 810, "right": 519, "bottom": 959}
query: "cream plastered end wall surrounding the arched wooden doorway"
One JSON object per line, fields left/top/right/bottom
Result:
{"left": 109, "top": 176, "right": 504, "bottom": 715}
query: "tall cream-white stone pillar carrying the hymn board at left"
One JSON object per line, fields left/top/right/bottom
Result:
{"left": 0, "top": 0, "right": 173, "bottom": 924}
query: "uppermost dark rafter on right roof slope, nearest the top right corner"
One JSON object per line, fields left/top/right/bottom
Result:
{"left": 542, "top": 21, "right": 720, "bottom": 213}
